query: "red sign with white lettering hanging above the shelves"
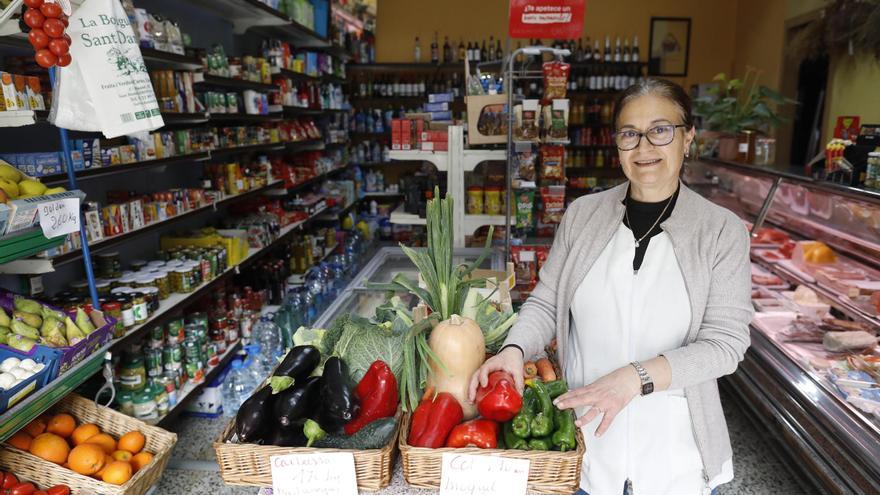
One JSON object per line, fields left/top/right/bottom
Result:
{"left": 508, "top": 0, "right": 586, "bottom": 39}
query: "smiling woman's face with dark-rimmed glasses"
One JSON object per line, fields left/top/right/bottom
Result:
{"left": 617, "top": 95, "right": 694, "bottom": 201}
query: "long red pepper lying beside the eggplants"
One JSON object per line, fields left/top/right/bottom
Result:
{"left": 344, "top": 360, "right": 398, "bottom": 435}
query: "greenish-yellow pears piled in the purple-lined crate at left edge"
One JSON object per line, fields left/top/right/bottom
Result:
{"left": 0, "top": 296, "right": 96, "bottom": 352}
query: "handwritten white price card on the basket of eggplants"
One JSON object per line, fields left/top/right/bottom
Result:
{"left": 270, "top": 452, "right": 358, "bottom": 495}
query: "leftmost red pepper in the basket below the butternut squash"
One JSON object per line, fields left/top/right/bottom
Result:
{"left": 407, "top": 392, "right": 464, "bottom": 449}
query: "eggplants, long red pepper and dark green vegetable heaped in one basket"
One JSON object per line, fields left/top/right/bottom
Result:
{"left": 235, "top": 345, "right": 398, "bottom": 449}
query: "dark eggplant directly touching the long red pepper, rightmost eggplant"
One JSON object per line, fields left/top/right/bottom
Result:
{"left": 314, "top": 356, "right": 360, "bottom": 433}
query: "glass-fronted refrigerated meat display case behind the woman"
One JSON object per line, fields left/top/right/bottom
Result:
{"left": 685, "top": 159, "right": 880, "bottom": 494}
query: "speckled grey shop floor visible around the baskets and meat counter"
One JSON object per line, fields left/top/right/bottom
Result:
{"left": 155, "top": 396, "right": 805, "bottom": 495}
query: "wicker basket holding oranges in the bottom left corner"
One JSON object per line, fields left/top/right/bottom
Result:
{"left": 0, "top": 394, "right": 177, "bottom": 495}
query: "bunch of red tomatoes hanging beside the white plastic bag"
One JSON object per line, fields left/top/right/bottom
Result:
{"left": 21, "top": 0, "right": 71, "bottom": 69}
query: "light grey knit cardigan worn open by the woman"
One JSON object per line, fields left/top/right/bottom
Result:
{"left": 505, "top": 183, "right": 753, "bottom": 480}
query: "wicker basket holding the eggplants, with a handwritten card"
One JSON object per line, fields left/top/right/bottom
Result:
{"left": 214, "top": 412, "right": 401, "bottom": 491}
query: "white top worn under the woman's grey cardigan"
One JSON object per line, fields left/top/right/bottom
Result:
{"left": 565, "top": 223, "right": 733, "bottom": 495}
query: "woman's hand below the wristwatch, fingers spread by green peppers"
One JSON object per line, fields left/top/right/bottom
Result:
{"left": 553, "top": 366, "right": 641, "bottom": 437}
